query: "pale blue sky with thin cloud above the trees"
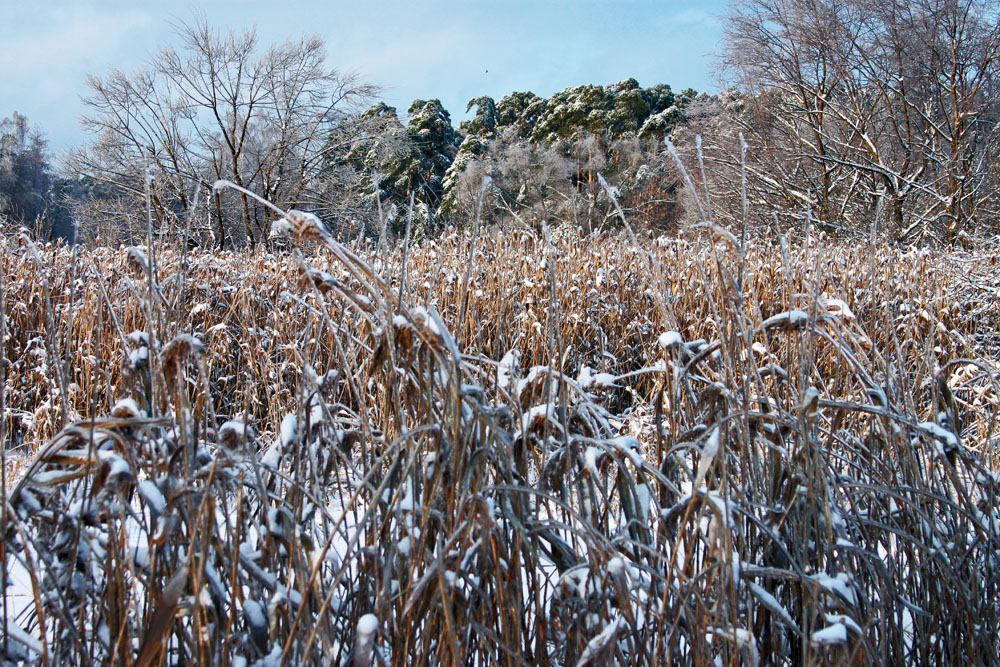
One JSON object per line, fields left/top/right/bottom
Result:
{"left": 0, "top": 0, "right": 725, "bottom": 152}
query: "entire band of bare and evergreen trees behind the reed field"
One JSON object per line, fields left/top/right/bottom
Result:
{"left": 0, "top": 0, "right": 1000, "bottom": 247}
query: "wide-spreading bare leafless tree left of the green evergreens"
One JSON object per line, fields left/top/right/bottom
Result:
{"left": 69, "top": 21, "right": 376, "bottom": 246}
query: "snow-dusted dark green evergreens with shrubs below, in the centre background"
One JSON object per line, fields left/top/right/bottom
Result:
{"left": 338, "top": 79, "right": 697, "bottom": 234}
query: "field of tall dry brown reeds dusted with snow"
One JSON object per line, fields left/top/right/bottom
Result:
{"left": 0, "top": 207, "right": 1000, "bottom": 665}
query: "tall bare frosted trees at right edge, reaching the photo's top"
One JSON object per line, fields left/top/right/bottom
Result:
{"left": 722, "top": 0, "right": 1000, "bottom": 240}
